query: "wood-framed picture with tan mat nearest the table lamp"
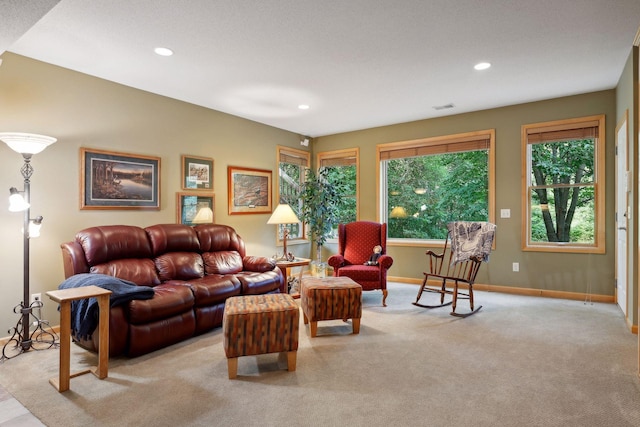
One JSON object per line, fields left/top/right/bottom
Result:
{"left": 227, "top": 166, "right": 271, "bottom": 215}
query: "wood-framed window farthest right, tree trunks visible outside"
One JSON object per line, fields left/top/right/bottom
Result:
{"left": 522, "top": 115, "right": 605, "bottom": 253}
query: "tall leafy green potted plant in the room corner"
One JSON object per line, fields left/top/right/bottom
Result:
{"left": 300, "top": 167, "right": 342, "bottom": 275}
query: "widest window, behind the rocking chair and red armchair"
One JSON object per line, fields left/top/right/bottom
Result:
{"left": 378, "top": 130, "right": 495, "bottom": 243}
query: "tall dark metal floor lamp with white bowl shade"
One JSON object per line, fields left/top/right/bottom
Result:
{"left": 0, "top": 133, "right": 57, "bottom": 360}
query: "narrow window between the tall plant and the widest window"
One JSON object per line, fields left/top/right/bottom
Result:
{"left": 317, "top": 148, "right": 360, "bottom": 239}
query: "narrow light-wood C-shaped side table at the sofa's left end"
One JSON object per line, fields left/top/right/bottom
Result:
{"left": 47, "top": 286, "right": 111, "bottom": 392}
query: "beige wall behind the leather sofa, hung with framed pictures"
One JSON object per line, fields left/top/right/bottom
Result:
{"left": 0, "top": 53, "right": 308, "bottom": 337}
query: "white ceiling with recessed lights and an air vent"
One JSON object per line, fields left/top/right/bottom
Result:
{"left": 0, "top": 0, "right": 640, "bottom": 137}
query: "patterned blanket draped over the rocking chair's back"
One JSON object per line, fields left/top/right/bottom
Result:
{"left": 447, "top": 221, "right": 496, "bottom": 265}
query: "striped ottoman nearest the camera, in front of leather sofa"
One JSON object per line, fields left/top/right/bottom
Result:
{"left": 222, "top": 294, "right": 300, "bottom": 379}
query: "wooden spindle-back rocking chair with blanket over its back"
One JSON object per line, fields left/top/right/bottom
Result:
{"left": 413, "top": 222, "right": 495, "bottom": 317}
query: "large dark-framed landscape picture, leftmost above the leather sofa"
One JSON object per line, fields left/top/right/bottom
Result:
{"left": 80, "top": 148, "right": 160, "bottom": 209}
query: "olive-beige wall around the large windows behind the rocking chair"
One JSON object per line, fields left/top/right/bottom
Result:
{"left": 313, "top": 90, "right": 616, "bottom": 298}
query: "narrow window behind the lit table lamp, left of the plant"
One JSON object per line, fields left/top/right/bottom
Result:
{"left": 277, "top": 146, "right": 311, "bottom": 242}
